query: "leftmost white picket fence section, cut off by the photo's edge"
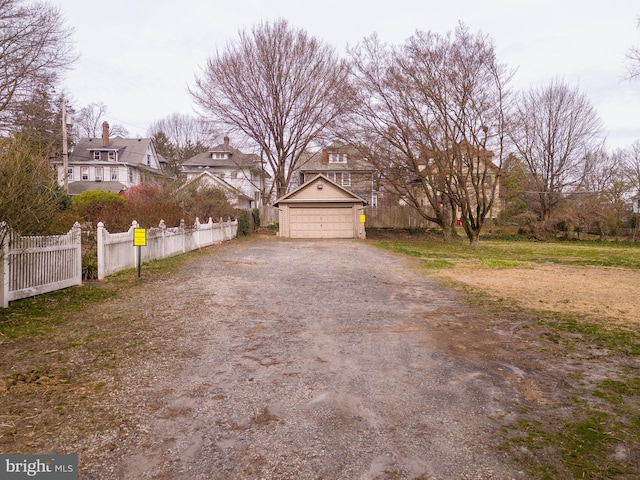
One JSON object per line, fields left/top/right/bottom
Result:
{"left": 0, "top": 222, "right": 82, "bottom": 308}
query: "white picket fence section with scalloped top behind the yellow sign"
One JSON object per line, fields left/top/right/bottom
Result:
{"left": 97, "top": 218, "right": 238, "bottom": 280}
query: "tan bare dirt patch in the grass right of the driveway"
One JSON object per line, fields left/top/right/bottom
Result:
{"left": 433, "top": 265, "right": 640, "bottom": 324}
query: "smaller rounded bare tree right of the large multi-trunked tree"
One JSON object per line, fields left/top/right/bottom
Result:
{"left": 512, "top": 80, "right": 603, "bottom": 222}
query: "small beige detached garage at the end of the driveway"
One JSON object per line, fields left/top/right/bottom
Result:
{"left": 274, "top": 175, "right": 367, "bottom": 238}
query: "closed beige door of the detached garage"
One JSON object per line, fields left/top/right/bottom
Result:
{"left": 289, "top": 207, "right": 353, "bottom": 238}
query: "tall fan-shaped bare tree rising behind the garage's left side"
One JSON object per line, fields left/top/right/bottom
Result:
{"left": 191, "top": 20, "right": 350, "bottom": 197}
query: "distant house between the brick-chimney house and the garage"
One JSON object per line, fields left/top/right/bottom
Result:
{"left": 181, "top": 137, "right": 270, "bottom": 208}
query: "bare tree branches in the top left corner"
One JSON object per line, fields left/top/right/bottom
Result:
{"left": 0, "top": 0, "right": 76, "bottom": 128}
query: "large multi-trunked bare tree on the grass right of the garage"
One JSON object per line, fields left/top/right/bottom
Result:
{"left": 352, "top": 25, "right": 510, "bottom": 246}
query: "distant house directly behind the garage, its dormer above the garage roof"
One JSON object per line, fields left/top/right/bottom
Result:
{"left": 298, "top": 143, "right": 381, "bottom": 207}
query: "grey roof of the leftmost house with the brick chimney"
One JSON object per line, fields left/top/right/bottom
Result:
{"left": 69, "top": 137, "right": 158, "bottom": 165}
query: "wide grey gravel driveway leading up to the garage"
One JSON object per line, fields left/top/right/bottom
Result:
{"left": 86, "top": 239, "right": 523, "bottom": 480}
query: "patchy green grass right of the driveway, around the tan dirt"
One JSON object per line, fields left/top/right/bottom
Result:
{"left": 374, "top": 238, "right": 640, "bottom": 480}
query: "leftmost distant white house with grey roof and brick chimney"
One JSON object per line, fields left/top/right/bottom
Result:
{"left": 55, "top": 122, "right": 166, "bottom": 195}
